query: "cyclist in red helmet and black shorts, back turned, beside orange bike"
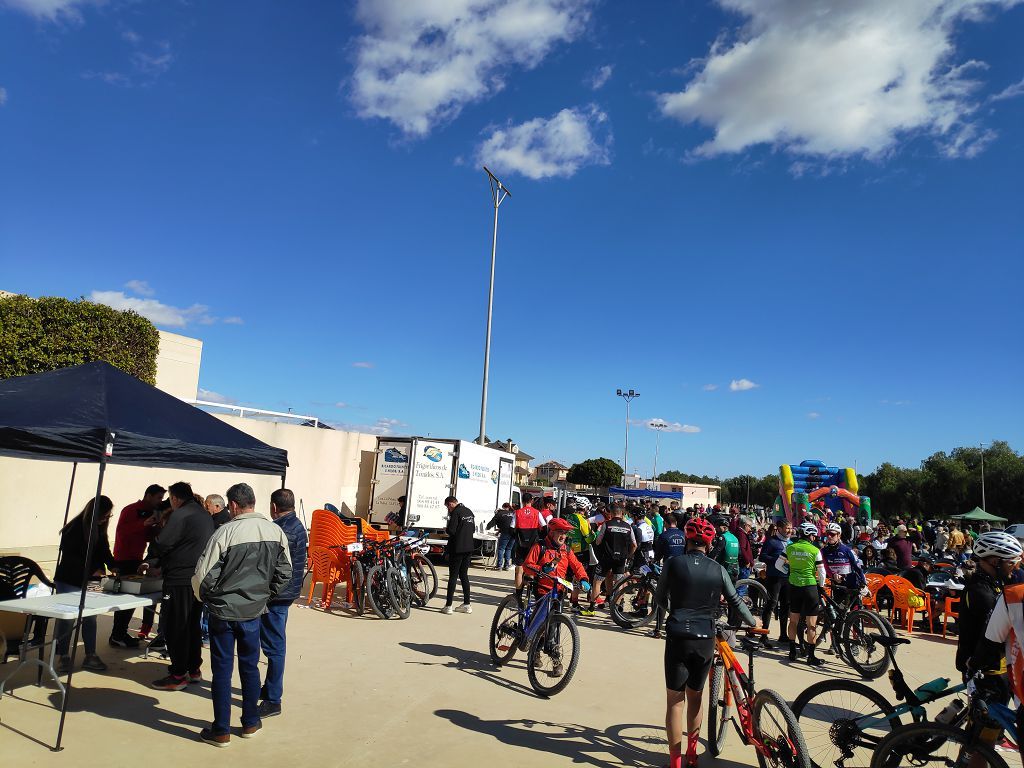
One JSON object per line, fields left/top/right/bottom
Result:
{"left": 655, "top": 517, "right": 757, "bottom": 768}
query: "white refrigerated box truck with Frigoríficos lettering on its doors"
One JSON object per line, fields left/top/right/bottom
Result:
{"left": 370, "top": 437, "right": 521, "bottom": 554}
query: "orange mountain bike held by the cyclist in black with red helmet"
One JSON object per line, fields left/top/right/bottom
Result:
{"left": 708, "top": 624, "right": 811, "bottom": 768}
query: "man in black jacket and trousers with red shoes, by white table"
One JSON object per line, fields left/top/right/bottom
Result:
{"left": 138, "top": 482, "right": 216, "bottom": 690}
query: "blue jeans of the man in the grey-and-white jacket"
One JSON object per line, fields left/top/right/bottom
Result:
{"left": 206, "top": 611, "right": 260, "bottom": 735}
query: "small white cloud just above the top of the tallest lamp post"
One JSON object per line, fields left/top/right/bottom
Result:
{"left": 476, "top": 105, "right": 611, "bottom": 179}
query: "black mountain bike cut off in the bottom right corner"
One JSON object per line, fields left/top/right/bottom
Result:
{"left": 870, "top": 681, "right": 1020, "bottom": 768}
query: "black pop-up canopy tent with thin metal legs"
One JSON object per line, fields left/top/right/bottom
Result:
{"left": 0, "top": 361, "right": 288, "bottom": 751}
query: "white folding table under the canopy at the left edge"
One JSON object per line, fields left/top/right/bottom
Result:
{"left": 0, "top": 592, "right": 161, "bottom": 698}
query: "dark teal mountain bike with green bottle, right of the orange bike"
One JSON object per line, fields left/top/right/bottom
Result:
{"left": 793, "top": 635, "right": 967, "bottom": 768}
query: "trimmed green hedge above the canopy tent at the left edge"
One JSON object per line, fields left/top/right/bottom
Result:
{"left": 0, "top": 296, "right": 160, "bottom": 384}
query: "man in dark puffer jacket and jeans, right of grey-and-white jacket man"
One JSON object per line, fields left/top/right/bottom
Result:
{"left": 259, "top": 488, "right": 309, "bottom": 718}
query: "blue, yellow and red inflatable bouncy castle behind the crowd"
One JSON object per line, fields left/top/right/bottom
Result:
{"left": 775, "top": 459, "right": 871, "bottom": 525}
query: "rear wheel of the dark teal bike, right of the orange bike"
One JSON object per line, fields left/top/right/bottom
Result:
{"left": 793, "top": 680, "right": 902, "bottom": 768}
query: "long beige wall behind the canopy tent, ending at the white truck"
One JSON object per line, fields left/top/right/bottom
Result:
{"left": 0, "top": 416, "right": 377, "bottom": 560}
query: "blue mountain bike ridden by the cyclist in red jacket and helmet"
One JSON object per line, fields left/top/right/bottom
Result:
{"left": 488, "top": 565, "right": 580, "bottom": 698}
